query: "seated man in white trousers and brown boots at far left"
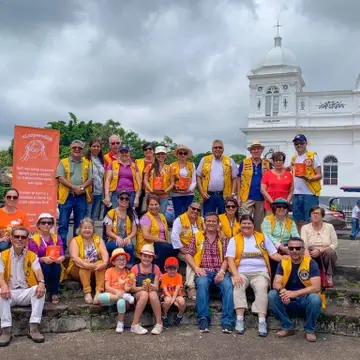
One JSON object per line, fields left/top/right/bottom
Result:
{"left": 0, "top": 226, "right": 46, "bottom": 347}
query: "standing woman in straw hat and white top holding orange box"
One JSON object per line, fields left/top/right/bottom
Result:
{"left": 170, "top": 145, "right": 196, "bottom": 218}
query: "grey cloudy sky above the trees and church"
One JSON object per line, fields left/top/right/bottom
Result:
{"left": 0, "top": 0, "right": 360, "bottom": 153}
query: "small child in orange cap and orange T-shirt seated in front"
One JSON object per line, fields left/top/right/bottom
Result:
{"left": 160, "top": 257, "right": 186, "bottom": 328}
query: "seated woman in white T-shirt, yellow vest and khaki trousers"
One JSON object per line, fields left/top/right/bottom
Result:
{"left": 226, "top": 215, "right": 281, "bottom": 337}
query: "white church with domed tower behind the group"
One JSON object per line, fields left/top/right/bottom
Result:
{"left": 241, "top": 28, "right": 360, "bottom": 200}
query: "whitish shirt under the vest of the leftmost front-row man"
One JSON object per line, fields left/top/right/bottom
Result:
{"left": 0, "top": 247, "right": 40, "bottom": 290}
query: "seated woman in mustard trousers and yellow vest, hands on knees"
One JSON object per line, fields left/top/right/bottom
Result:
{"left": 67, "top": 217, "right": 109, "bottom": 304}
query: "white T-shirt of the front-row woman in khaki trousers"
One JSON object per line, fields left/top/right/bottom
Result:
{"left": 226, "top": 235, "right": 277, "bottom": 274}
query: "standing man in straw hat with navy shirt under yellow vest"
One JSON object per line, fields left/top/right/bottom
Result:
{"left": 238, "top": 140, "right": 271, "bottom": 231}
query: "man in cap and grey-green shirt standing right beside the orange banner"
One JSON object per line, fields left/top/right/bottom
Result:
{"left": 56, "top": 140, "right": 93, "bottom": 250}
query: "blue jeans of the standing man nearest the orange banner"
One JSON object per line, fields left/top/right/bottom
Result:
{"left": 58, "top": 194, "right": 87, "bottom": 250}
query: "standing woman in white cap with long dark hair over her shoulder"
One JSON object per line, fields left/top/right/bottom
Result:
{"left": 144, "top": 146, "right": 174, "bottom": 214}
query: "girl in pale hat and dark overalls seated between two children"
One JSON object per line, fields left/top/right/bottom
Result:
{"left": 131, "top": 244, "right": 163, "bottom": 335}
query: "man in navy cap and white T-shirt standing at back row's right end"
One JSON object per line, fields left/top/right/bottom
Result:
{"left": 291, "top": 134, "right": 322, "bottom": 229}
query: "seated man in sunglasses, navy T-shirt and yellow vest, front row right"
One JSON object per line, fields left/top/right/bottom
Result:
{"left": 268, "top": 237, "right": 322, "bottom": 342}
